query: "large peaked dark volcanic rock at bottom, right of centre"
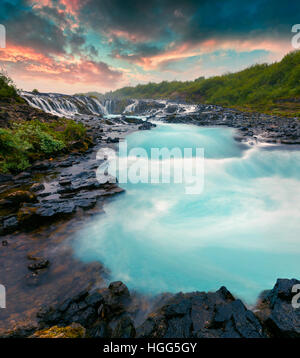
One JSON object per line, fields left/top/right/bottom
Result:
{"left": 137, "top": 287, "right": 264, "bottom": 338}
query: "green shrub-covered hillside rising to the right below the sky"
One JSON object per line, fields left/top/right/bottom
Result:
{"left": 105, "top": 51, "right": 300, "bottom": 117}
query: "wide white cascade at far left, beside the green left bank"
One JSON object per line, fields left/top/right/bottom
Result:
{"left": 20, "top": 92, "right": 108, "bottom": 118}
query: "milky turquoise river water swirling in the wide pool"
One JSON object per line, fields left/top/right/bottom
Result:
{"left": 74, "top": 124, "right": 300, "bottom": 304}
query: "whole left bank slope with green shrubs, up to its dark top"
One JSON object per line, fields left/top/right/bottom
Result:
{"left": 0, "top": 69, "right": 90, "bottom": 173}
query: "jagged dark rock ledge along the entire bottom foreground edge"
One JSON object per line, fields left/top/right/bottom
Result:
{"left": 2, "top": 279, "right": 300, "bottom": 338}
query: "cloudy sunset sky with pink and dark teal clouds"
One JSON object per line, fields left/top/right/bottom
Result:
{"left": 0, "top": 0, "right": 300, "bottom": 94}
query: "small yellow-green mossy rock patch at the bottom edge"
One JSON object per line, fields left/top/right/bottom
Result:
{"left": 30, "top": 323, "right": 86, "bottom": 338}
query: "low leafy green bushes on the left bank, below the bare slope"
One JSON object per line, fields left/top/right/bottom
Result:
{"left": 0, "top": 118, "right": 86, "bottom": 173}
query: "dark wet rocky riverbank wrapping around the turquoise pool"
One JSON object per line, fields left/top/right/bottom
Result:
{"left": 0, "top": 100, "right": 300, "bottom": 337}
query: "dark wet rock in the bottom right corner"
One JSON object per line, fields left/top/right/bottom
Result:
{"left": 256, "top": 279, "right": 300, "bottom": 338}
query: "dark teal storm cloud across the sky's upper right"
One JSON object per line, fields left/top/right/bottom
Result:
{"left": 78, "top": 0, "right": 300, "bottom": 57}
